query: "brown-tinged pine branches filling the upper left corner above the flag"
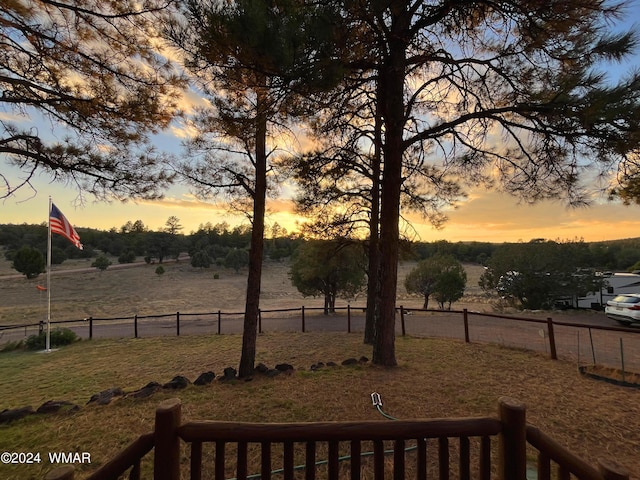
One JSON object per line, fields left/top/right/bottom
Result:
{"left": 0, "top": 0, "right": 184, "bottom": 198}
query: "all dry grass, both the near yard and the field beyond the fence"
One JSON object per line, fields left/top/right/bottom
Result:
{"left": 0, "top": 253, "right": 640, "bottom": 480}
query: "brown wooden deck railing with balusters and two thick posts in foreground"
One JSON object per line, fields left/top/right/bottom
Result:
{"left": 46, "top": 398, "right": 629, "bottom": 480}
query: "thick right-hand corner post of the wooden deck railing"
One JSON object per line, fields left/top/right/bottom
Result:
{"left": 498, "top": 397, "right": 527, "bottom": 480}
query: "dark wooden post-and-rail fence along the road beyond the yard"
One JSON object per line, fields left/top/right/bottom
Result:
{"left": 0, "top": 305, "right": 640, "bottom": 380}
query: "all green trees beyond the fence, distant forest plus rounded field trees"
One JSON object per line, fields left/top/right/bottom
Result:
{"left": 5, "top": 217, "right": 640, "bottom": 313}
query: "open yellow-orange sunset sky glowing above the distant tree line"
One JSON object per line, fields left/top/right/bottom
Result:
{"left": 0, "top": 0, "right": 640, "bottom": 242}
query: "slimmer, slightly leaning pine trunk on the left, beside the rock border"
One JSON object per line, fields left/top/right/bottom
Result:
{"left": 238, "top": 91, "right": 267, "bottom": 377}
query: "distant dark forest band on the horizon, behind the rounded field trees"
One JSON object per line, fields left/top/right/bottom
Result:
{"left": 0, "top": 217, "right": 640, "bottom": 271}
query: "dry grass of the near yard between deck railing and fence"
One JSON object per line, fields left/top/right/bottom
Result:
{"left": 0, "top": 333, "right": 640, "bottom": 479}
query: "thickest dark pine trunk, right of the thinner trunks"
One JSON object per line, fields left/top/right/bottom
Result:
{"left": 372, "top": 5, "right": 411, "bottom": 366}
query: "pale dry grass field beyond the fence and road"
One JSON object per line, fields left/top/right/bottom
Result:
{"left": 0, "top": 257, "right": 489, "bottom": 325}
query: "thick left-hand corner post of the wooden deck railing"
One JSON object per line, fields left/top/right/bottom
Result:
{"left": 153, "top": 398, "right": 181, "bottom": 480}
